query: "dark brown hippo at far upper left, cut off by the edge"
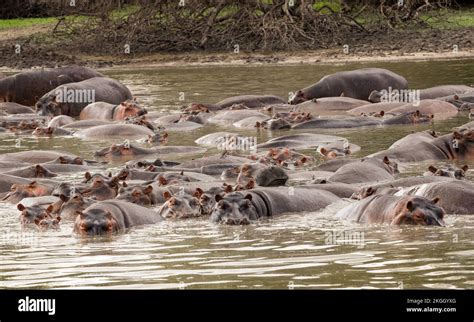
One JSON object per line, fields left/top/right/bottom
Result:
{"left": 0, "top": 65, "right": 104, "bottom": 106}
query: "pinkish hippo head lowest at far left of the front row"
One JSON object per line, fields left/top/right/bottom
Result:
{"left": 16, "top": 203, "right": 61, "bottom": 230}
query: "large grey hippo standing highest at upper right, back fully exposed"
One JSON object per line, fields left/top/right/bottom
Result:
{"left": 290, "top": 68, "right": 408, "bottom": 104}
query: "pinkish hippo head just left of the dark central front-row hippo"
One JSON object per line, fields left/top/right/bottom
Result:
{"left": 160, "top": 191, "right": 202, "bottom": 219}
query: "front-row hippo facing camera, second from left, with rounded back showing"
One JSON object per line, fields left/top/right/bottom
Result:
{"left": 74, "top": 200, "right": 163, "bottom": 236}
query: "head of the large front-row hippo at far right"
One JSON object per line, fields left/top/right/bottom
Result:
{"left": 391, "top": 197, "right": 445, "bottom": 226}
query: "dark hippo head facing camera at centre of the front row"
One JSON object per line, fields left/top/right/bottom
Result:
{"left": 211, "top": 192, "right": 258, "bottom": 225}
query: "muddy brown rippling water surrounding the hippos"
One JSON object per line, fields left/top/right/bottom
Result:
{"left": 0, "top": 60, "right": 474, "bottom": 289}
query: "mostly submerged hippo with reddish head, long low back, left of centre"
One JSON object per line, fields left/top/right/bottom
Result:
{"left": 94, "top": 142, "right": 206, "bottom": 158}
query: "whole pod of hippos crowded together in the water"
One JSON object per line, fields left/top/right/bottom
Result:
{"left": 0, "top": 66, "right": 474, "bottom": 236}
